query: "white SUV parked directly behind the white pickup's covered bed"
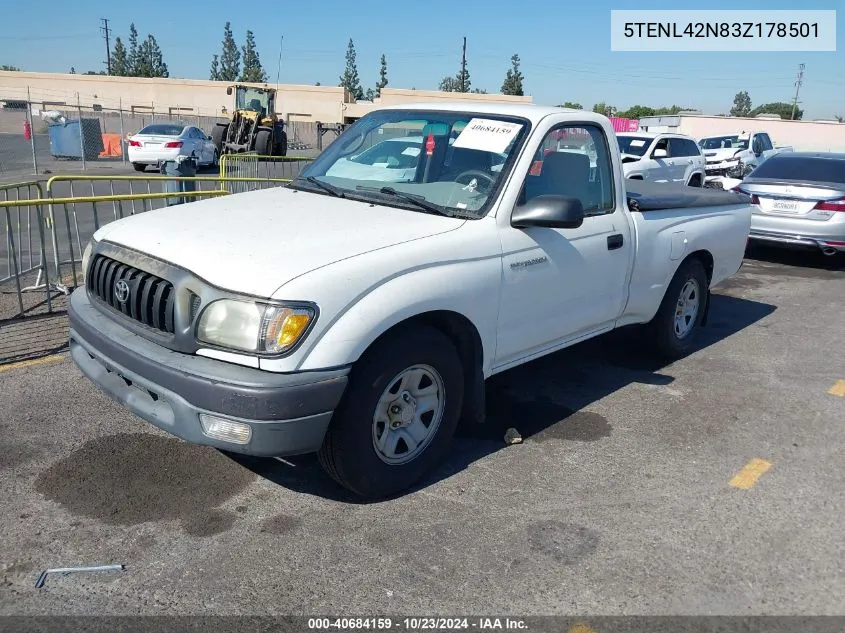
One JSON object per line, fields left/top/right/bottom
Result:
{"left": 616, "top": 132, "right": 704, "bottom": 187}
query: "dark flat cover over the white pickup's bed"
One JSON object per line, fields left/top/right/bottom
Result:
{"left": 625, "top": 180, "right": 751, "bottom": 212}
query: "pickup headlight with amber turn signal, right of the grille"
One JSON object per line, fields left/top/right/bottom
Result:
{"left": 197, "top": 299, "right": 316, "bottom": 354}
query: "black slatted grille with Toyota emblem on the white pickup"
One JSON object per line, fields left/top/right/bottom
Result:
{"left": 87, "top": 255, "right": 176, "bottom": 334}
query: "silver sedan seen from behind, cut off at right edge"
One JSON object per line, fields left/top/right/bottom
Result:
{"left": 736, "top": 152, "right": 845, "bottom": 255}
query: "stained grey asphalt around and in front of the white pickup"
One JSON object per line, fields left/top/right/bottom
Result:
{"left": 0, "top": 244, "right": 845, "bottom": 615}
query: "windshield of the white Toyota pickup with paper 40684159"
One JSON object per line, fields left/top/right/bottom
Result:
{"left": 289, "top": 110, "right": 530, "bottom": 217}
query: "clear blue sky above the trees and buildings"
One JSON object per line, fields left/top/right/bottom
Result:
{"left": 0, "top": 0, "right": 845, "bottom": 119}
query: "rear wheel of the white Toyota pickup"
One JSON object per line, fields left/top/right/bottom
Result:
{"left": 647, "top": 258, "right": 708, "bottom": 360}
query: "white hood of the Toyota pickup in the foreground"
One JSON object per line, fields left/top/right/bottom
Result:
{"left": 94, "top": 187, "right": 466, "bottom": 297}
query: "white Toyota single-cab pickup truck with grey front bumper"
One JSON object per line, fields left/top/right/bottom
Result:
{"left": 69, "top": 103, "right": 751, "bottom": 498}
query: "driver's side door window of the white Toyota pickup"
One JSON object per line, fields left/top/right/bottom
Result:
{"left": 520, "top": 124, "right": 616, "bottom": 215}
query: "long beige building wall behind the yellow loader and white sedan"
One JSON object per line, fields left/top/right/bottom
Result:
{"left": 0, "top": 71, "right": 532, "bottom": 123}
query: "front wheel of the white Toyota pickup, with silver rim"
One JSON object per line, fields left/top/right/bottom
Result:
{"left": 317, "top": 327, "right": 464, "bottom": 499}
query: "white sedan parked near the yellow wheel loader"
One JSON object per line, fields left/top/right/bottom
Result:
{"left": 127, "top": 123, "right": 218, "bottom": 171}
